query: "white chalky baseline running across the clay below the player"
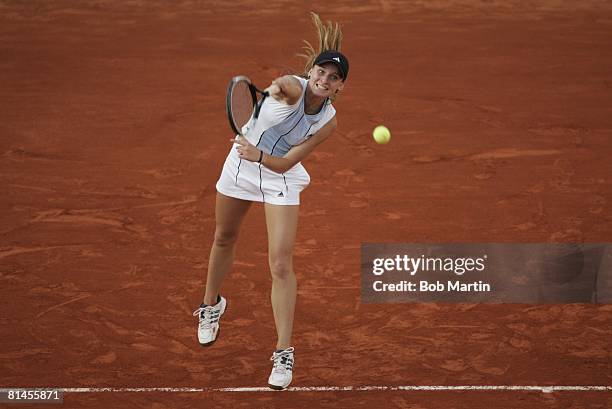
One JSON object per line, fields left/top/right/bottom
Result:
{"left": 20, "top": 385, "right": 612, "bottom": 393}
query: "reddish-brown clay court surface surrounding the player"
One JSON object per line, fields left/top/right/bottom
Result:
{"left": 0, "top": 0, "right": 612, "bottom": 409}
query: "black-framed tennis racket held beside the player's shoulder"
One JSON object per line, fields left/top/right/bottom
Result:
{"left": 226, "top": 75, "right": 268, "bottom": 136}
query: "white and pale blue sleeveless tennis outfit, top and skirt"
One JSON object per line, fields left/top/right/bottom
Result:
{"left": 217, "top": 76, "right": 336, "bottom": 205}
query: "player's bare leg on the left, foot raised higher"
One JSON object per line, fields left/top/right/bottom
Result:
{"left": 204, "top": 192, "right": 251, "bottom": 305}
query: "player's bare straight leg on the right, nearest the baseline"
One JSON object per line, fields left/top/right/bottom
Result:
{"left": 265, "top": 204, "right": 299, "bottom": 349}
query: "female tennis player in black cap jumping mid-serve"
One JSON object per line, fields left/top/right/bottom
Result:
{"left": 194, "top": 13, "right": 349, "bottom": 390}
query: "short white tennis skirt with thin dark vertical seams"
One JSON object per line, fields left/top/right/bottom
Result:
{"left": 217, "top": 144, "right": 310, "bottom": 206}
